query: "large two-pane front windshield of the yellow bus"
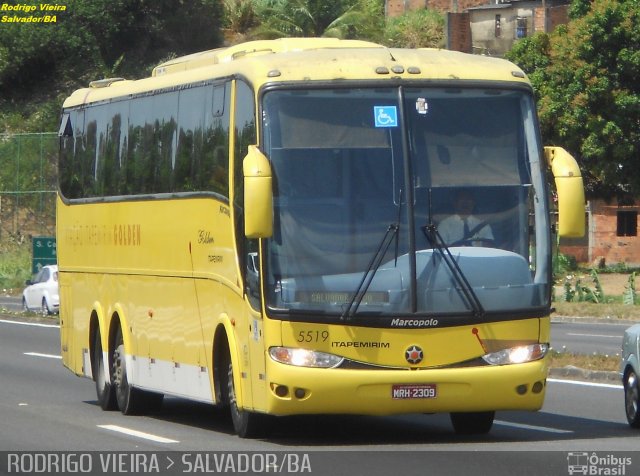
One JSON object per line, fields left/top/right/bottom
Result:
{"left": 262, "top": 87, "right": 550, "bottom": 319}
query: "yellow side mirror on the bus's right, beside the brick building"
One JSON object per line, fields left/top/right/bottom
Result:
{"left": 544, "top": 147, "right": 585, "bottom": 238}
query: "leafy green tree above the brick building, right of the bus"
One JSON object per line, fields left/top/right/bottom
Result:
{"left": 509, "top": 0, "right": 640, "bottom": 197}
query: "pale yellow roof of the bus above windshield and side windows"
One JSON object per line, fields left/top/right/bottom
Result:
{"left": 64, "top": 38, "right": 529, "bottom": 107}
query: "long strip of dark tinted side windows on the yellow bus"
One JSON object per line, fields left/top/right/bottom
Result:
{"left": 59, "top": 81, "right": 230, "bottom": 199}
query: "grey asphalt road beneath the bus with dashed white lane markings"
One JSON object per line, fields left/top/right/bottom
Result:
{"left": 0, "top": 320, "right": 640, "bottom": 475}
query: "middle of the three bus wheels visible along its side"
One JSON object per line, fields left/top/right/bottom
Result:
{"left": 111, "top": 328, "right": 164, "bottom": 415}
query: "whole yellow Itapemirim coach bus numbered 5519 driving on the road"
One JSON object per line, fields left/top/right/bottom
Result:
{"left": 57, "top": 38, "right": 584, "bottom": 437}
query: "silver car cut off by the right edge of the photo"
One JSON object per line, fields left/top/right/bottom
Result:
{"left": 620, "top": 324, "right": 640, "bottom": 428}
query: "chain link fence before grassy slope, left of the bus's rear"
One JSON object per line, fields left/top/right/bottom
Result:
{"left": 0, "top": 132, "right": 58, "bottom": 243}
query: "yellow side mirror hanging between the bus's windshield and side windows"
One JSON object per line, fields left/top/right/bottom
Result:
{"left": 242, "top": 145, "right": 273, "bottom": 238}
